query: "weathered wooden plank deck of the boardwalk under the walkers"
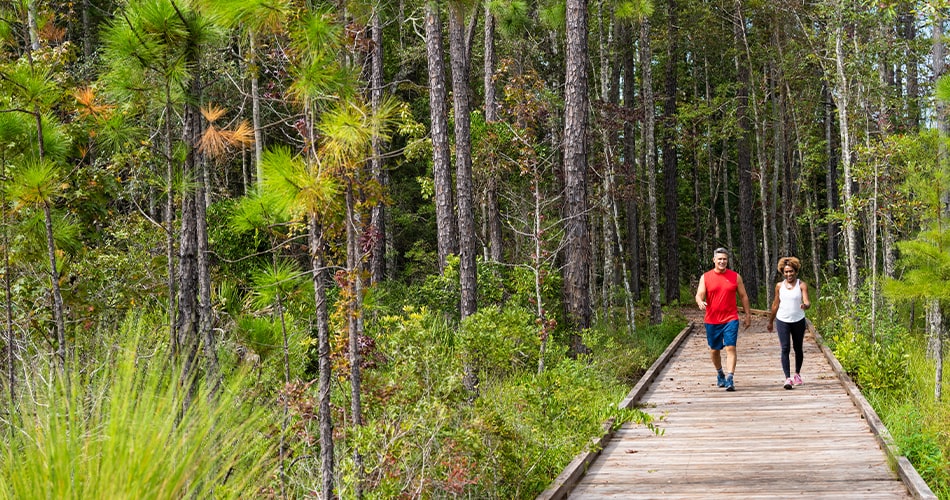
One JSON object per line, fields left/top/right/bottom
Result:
{"left": 541, "top": 310, "right": 932, "bottom": 499}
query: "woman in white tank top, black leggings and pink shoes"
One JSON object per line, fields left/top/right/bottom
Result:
{"left": 768, "top": 257, "right": 811, "bottom": 389}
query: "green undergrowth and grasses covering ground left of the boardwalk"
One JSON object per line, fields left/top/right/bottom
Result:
{"left": 0, "top": 220, "right": 686, "bottom": 499}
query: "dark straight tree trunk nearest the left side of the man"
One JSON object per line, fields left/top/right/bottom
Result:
{"left": 663, "top": 0, "right": 680, "bottom": 304}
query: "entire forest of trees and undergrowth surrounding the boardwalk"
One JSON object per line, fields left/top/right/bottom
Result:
{"left": 0, "top": 0, "right": 950, "bottom": 498}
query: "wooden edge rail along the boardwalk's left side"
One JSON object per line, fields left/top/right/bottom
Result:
{"left": 538, "top": 322, "right": 696, "bottom": 500}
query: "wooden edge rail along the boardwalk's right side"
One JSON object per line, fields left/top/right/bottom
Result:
{"left": 808, "top": 321, "right": 937, "bottom": 500}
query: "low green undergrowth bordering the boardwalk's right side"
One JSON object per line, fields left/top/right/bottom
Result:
{"left": 812, "top": 282, "right": 950, "bottom": 499}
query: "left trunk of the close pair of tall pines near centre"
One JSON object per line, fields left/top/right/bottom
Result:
{"left": 425, "top": 0, "right": 459, "bottom": 272}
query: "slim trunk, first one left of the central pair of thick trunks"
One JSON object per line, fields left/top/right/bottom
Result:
{"left": 369, "top": 11, "right": 390, "bottom": 283}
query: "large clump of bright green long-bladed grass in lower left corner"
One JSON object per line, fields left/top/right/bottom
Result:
{"left": 0, "top": 318, "right": 274, "bottom": 499}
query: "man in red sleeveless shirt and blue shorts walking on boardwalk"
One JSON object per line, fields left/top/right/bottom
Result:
{"left": 696, "top": 248, "right": 752, "bottom": 391}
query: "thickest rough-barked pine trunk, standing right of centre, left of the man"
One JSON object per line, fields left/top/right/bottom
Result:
{"left": 562, "top": 0, "right": 591, "bottom": 340}
